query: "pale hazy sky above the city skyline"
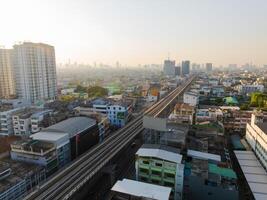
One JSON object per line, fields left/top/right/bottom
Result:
{"left": 0, "top": 0, "right": 267, "bottom": 65}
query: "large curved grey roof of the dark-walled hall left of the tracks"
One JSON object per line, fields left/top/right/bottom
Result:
{"left": 44, "top": 117, "right": 96, "bottom": 137}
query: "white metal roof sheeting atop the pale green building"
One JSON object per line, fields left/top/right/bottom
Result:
{"left": 136, "top": 148, "right": 183, "bottom": 163}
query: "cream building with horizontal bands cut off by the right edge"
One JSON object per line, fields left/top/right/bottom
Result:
{"left": 246, "top": 111, "right": 267, "bottom": 170}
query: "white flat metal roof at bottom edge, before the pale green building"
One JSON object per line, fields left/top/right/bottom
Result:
{"left": 111, "top": 179, "right": 171, "bottom": 200}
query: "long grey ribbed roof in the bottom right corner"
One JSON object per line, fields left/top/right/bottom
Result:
{"left": 234, "top": 151, "right": 267, "bottom": 200}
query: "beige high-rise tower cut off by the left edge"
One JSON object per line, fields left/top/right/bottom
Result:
{"left": 0, "top": 49, "right": 15, "bottom": 98}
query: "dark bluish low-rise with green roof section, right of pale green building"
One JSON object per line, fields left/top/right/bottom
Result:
{"left": 184, "top": 151, "right": 239, "bottom": 200}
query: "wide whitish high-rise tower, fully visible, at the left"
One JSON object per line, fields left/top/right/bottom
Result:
{"left": 14, "top": 42, "right": 56, "bottom": 102}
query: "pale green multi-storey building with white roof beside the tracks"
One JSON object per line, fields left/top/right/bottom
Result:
{"left": 135, "top": 144, "right": 184, "bottom": 200}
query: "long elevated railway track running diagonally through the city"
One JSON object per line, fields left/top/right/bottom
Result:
{"left": 25, "top": 76, "right": 196, "bottom": 200}
